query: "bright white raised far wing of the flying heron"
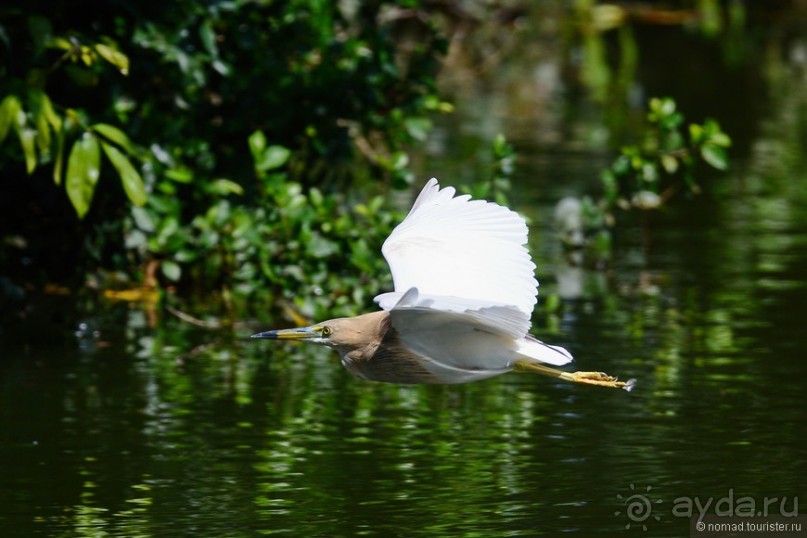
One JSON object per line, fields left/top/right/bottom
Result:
{"left": 377, "top": 179, "right": 538, "bottom": 319}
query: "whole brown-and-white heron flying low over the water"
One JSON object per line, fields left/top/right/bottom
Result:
{"left": 253, "top": 179, "right": 632, "bottom": 389}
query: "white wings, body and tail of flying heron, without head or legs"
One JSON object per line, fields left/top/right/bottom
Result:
{"left": 376, "top": 184, "right": 572, "bottom": 376}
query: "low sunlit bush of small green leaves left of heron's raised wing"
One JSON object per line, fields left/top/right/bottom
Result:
{"left": 127, "top": 131, "right": 399, "bottom": 319}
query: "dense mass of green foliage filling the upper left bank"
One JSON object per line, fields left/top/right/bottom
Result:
{"left": 0, "top": 0, "right": 450, "bottom": 308}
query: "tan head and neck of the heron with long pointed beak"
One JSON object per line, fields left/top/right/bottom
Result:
{"left": 252, "top": 312, "right": 389, "bottom": 353}
